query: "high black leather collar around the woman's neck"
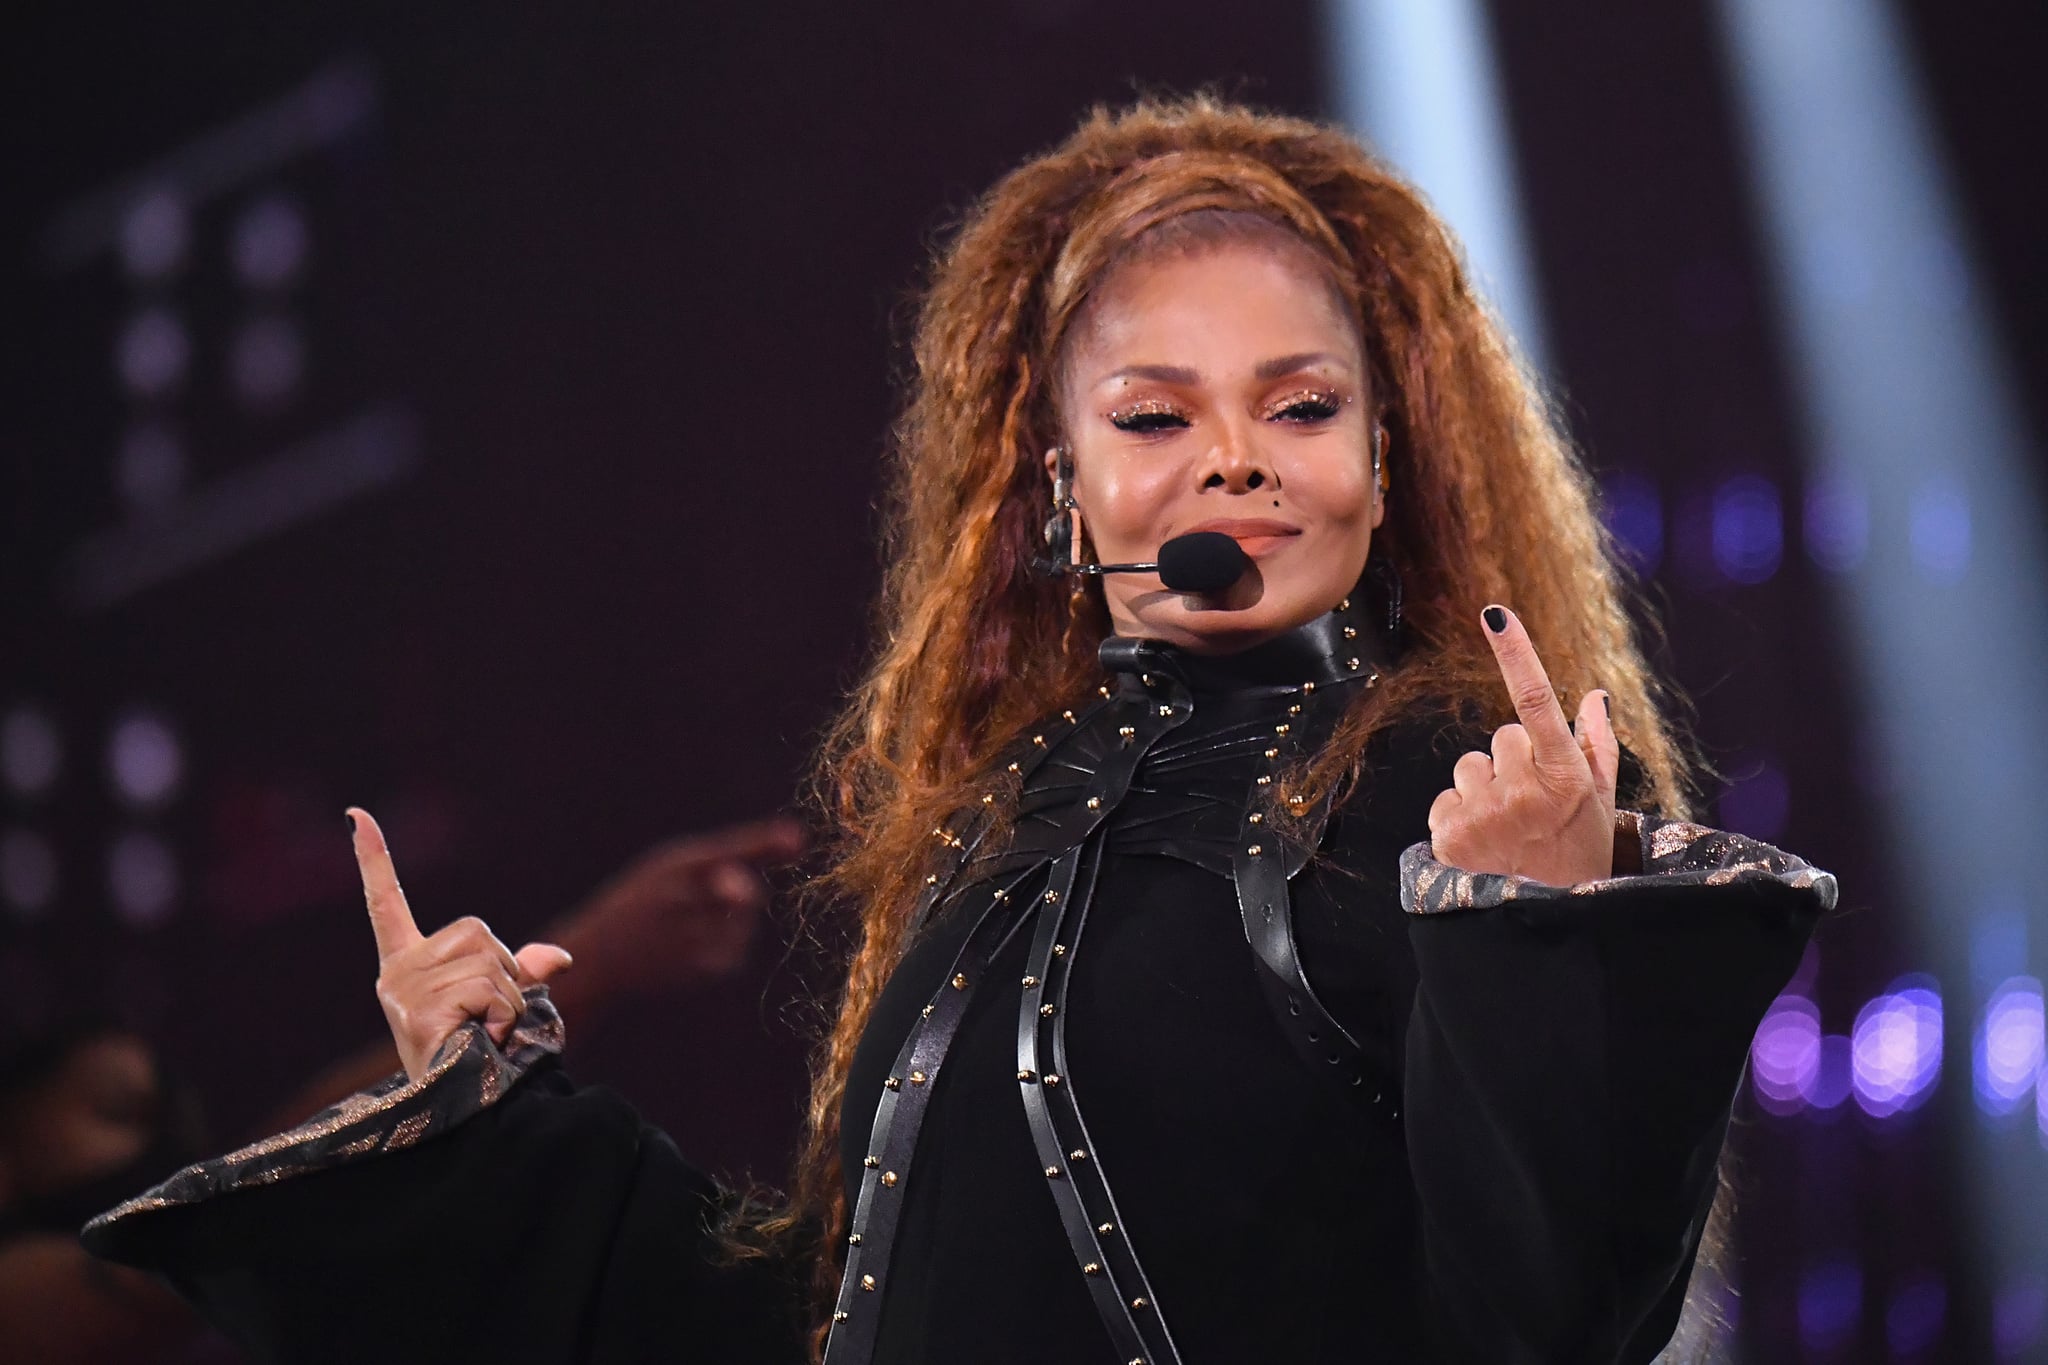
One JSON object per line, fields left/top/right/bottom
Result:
{"left": 1096, "top": 591, "right": 1389, "bottom": 694}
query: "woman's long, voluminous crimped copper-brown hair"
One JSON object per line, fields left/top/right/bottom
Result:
{"left": 753, "top": 96, "right": 1692, "bottom": 1342}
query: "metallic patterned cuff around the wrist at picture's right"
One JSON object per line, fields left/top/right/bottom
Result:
{"left": 1401, "top": 810, "right": 1839, "bottom": 915}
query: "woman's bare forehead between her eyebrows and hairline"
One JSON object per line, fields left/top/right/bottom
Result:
{"left": 1061, "top": 231, "right": 1362, "bottom": 383}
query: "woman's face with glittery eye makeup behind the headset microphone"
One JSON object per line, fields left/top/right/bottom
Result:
{"left": 1047, "top": 239, "right": 1384, "bottom": 653}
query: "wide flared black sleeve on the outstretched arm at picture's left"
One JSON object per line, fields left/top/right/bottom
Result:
{"left": 82, "top": 988, "right": 803, "bottom": 1365}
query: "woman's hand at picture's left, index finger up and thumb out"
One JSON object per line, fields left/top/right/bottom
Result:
{"left": 348, "top": 806, "right": 571, "bottom": 1081}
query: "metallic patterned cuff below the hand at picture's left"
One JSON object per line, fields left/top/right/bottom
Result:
{"left": 86, "top": 986, "right": 563, "bottom": 1234}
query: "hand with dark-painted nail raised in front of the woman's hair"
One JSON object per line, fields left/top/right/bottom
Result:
{"left": 1430, "top": 606, "right": 1620, "bottom": 886}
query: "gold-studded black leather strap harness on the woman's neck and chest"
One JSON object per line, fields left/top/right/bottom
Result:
{"left": 825, "top": 602, "right": 1399, "bottom": 1365}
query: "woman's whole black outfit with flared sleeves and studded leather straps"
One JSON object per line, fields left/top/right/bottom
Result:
{"left": 86, "top": 610, "right": 1835, "bottom": 1365}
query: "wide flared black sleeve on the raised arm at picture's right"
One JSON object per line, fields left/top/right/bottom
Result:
{"left": 1401, "top": 810, "right": 1837, "bottom": 1365}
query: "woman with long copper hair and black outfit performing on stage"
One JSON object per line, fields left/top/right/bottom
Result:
{"left": 88, "top": 100, "right": 1835, "bottom": 1365}
